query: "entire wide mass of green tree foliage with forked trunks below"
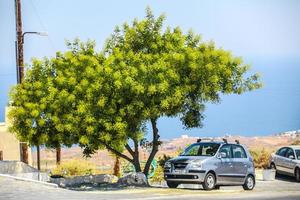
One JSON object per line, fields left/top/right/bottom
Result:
{"left": 11, "top": 9, "right": 261, "bottom": 177}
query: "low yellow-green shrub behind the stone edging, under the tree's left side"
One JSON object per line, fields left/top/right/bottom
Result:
{"left": 51, "top": 160, "right": 96, "bottom": 177}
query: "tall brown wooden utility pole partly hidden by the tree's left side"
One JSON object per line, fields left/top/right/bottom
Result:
{"left": 15, "top": 0, "right": 28, "bottom": 164}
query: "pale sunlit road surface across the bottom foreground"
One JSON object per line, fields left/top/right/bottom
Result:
{"left": 0, "top": 177, "right": 300, "bottom": 200}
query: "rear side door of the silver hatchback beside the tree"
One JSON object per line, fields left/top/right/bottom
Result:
{"left": 231, "top": 145, "right": 250, "bottom": 183}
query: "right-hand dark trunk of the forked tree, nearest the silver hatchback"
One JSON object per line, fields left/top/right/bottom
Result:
{"left": 144, "top": 119, "right": 159, "bottom": 176}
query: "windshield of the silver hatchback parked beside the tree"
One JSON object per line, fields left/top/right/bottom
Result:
{"left": 181, "top": 143, "right": 220, "bottom": 156}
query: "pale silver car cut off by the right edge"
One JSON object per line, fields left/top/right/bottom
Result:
{"left": 270, "top": 146, "right": 300, "bottom": 182}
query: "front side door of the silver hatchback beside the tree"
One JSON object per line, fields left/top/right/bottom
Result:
{"left": 216, "top": 144, "right": 233, "bottom": 184}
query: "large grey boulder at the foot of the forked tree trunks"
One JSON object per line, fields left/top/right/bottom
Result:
{"left": 118, "top": 172, "right": 148, "bottom": 187}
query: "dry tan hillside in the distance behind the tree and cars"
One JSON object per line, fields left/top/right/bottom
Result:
{"left": 33, "top": 130, "right": 300, "bottom": 169}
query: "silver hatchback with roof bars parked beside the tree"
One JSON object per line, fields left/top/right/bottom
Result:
{"left": 164, "top": 139, "right": 255, "bottom": 190}
